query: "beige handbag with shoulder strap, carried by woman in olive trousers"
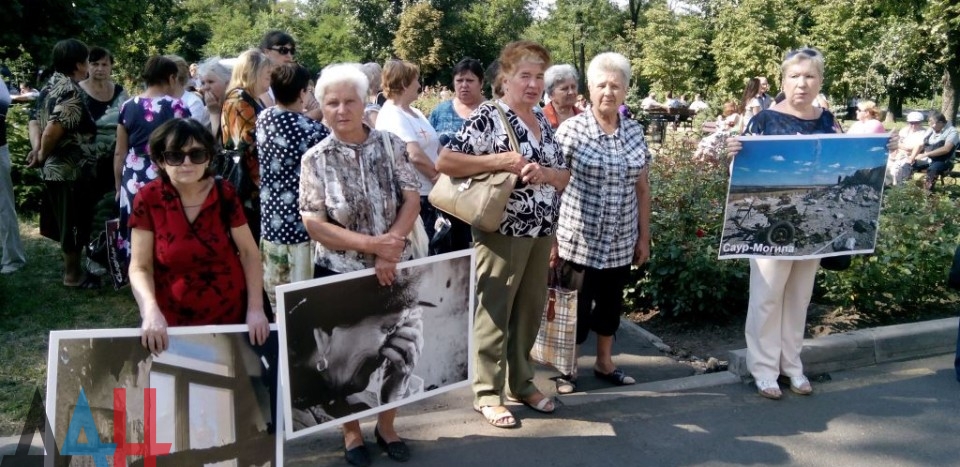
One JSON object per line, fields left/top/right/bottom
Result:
{"left": 427, "top": 102, "right": 520, "bottom": 232}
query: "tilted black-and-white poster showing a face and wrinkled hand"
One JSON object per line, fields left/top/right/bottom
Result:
{"left": 277, "top": 249, "right": 476, "bottom": 439}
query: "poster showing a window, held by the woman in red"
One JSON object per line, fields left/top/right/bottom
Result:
{"left": 46, "top": 325, "right": 283, "bottom": 467}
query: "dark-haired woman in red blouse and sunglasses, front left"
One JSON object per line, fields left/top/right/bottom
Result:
{"left": 129, "top": 119, "right": 270, "bottom": 354}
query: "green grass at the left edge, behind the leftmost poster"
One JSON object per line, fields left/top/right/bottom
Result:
{"left": 0, "top": 219, "right": 140, "bottom": 436}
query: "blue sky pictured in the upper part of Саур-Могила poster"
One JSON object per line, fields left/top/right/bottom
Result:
{"left": 730, "top": 134, "right": 889, "bottom": 186}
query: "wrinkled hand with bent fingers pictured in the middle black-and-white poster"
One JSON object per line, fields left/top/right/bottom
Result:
{"left": 380, "top": 307, "right": 423, "bottom": 403}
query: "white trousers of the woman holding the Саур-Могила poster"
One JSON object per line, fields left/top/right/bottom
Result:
{"left": 746, "top": 258, "right": 820, "bottom": 381}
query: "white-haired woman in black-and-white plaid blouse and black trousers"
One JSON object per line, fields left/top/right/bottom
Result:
{"left": 550, "top": 53, "right": 650, "bottom": 394}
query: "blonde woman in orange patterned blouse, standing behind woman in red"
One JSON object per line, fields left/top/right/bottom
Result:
{"left": 220, "top": 49, "right": 273, "bottom": 242}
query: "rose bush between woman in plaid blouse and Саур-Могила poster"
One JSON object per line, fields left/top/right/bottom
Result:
{"left": 626, "top": 133, "right": 750, "bottom": 320}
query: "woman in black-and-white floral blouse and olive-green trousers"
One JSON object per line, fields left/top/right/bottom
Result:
{"left": 437, "top": 41, "right": 570, "bottom": 428}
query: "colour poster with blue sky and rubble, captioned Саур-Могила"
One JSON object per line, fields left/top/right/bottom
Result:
{"left": 719, "top": 134, "right": 889, "bottom": 259}
